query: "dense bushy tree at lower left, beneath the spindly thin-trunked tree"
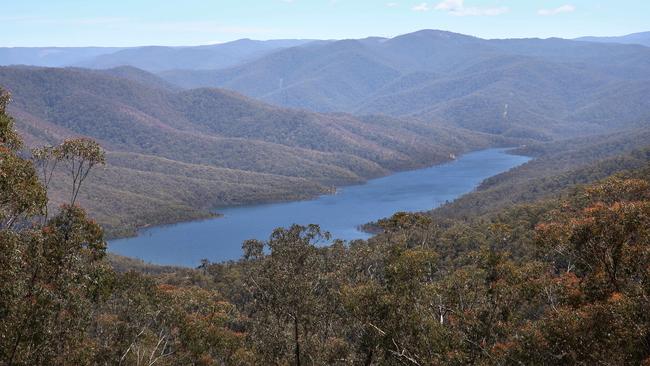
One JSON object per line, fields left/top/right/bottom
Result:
{"left": 1, "top": 207, "right": 111, "bottom": 364}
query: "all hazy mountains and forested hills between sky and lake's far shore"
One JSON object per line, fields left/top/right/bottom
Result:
{"left": 0, "top": 30, "right": 650, "bottom": 233}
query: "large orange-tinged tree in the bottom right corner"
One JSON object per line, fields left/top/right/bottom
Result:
{"left": 502, "top": 177, "right": 650, "bottom": 365}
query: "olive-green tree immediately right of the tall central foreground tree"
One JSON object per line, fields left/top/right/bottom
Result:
{"left": 341, "top": 213, "right": 445, "bottom": 365}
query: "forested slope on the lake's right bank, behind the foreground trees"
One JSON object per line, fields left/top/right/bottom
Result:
{"left": 432, "top": 129, "right": 650, "bottom": 218}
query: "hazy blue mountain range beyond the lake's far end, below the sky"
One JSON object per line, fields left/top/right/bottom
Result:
{"left": 160, "top": 30, "right": 650, "bottom": 140}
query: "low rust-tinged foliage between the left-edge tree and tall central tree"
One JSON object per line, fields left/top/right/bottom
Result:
{"left": 90, "top": 272, "right": 250, "bottom": 365}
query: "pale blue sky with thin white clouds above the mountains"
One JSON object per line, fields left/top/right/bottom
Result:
{"left": 0, "top": 0, "right": 650, "bottom": 47}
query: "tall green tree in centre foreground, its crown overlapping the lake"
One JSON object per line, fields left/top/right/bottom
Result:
{"left": 243, "top": 225, "right": 336, "bottom": 365}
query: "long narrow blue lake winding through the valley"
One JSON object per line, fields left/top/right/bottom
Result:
{"left": 109, "top": 149, "right": 529, "bottom": 266}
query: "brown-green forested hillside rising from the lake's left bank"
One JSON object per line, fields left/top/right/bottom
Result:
{"left": 0, "top": 67, "right": 498, "bottom": 233}
